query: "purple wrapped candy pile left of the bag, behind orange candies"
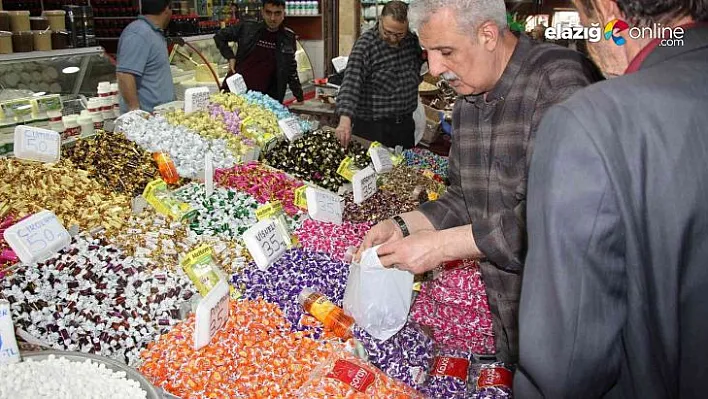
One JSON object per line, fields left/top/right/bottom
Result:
{"left": 232, "top": 248, "right": 349, "bottom": 335}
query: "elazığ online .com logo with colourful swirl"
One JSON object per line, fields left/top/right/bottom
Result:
{"left": 545, "top": 19, "right": 684, "bottom": 47}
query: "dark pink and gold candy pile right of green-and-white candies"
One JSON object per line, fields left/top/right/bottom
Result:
{"left": 214, "top": 162, "right": 302, "bottom": 215}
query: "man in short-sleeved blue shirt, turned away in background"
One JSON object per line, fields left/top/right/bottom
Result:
{"left": 116, "top": 0, "right": 175, "bottom": 112}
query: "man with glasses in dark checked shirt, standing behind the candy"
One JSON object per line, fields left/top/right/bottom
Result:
{"left": 336, "top": 0, "right": 423, "bottom": 148}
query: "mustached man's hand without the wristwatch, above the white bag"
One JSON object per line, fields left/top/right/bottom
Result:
{"left": 377, "top": 231, "right": 445, "bottom": 274}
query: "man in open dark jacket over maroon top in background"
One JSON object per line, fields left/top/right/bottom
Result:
{"left": 214, "top": 0, "right": 303, "bottom": 102}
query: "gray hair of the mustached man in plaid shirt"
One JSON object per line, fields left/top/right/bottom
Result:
{"left": 408, "top": 0, "right": 509, "bottom": 34}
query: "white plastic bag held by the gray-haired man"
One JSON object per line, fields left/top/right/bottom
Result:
{"left": 344, "top": 247, "right": 413, "bottom": 341}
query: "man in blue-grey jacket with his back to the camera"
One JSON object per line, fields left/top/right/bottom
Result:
{"left": 514, "top": 0, "right": 708, "bottom": 399}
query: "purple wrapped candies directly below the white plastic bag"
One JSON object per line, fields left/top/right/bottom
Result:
{"left": 353, "top": 322, "right": 433, "bottom": 389}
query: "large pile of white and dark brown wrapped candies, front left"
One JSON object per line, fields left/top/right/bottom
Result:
{"left": 2, "top": 237, "right": 194, "bottom": 365}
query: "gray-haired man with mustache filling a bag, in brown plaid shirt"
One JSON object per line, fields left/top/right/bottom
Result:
{"left": 358, "top": 0, "right": 601, "bottom": 364}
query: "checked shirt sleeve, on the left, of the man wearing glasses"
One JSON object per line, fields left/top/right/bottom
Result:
{"left": 337, "top": 35, "right": 370, "bottom": 119}
